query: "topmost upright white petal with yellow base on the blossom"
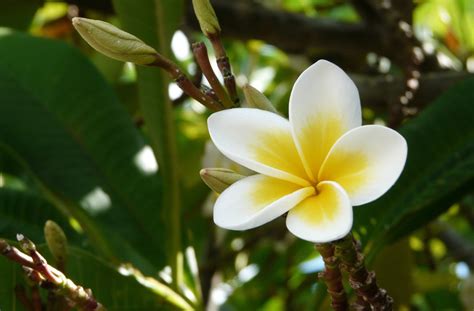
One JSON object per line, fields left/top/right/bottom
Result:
{"left": 289, "top": 60, "right": 362, "bottom": 181}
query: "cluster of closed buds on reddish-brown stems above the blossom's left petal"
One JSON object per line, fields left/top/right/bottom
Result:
{"left": 72, "top": 0, "right": 239, "bottom": 111}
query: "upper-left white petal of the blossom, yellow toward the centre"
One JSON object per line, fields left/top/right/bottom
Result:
{"left": 207, "top": 108, "right": 309, "bottom": 186}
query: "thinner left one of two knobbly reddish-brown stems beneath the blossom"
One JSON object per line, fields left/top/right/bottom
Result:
{"left": 315, "top": 243, "right": 349, "bottom": 311}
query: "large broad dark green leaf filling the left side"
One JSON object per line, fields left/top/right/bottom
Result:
{"left": 0, "top": 34, "right": 164, "bottom": 266}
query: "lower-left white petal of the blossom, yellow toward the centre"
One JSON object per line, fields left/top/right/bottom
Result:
{"left": 214, "top": 174, "right": 314, "bottom": 230}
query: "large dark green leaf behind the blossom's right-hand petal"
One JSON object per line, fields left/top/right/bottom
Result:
{"left": 355, "top": 79, "right": 474, "bottom": 255}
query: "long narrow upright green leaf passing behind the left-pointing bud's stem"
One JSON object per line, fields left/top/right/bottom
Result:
{"left": 113, "top": 0, "right": 184, "bottom": 287}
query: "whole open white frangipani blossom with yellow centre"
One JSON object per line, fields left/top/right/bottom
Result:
{"left": 208, "top": 60, "right": 407, "bottom": 243}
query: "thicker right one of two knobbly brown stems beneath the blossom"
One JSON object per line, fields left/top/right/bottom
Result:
{"left": 333, "top": 233, "right": 393, "bottom": 310}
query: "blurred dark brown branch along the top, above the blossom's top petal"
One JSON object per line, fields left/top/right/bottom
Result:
{"left": 186, "top": 0, "right": 383, "bottom": 54}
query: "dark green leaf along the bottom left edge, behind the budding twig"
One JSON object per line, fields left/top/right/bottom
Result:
{"left": 0, "top": 247, "right": 186, "bottom": 311}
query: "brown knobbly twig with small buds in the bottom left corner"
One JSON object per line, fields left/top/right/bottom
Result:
{"left": 0, "top": 221, "right": 106, "bottom": 311}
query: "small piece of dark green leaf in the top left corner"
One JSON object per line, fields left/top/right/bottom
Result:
{"left": 0, "top": 0, "right": 44, "bottom": 30}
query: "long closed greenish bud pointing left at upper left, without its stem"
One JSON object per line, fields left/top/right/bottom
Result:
{"left": 72, "top": 17, "right": 158, "bottom": 65}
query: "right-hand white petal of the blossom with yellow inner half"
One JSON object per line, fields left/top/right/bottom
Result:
{"left": 319, "top": 125, "right": 407, "bottom": 206}
